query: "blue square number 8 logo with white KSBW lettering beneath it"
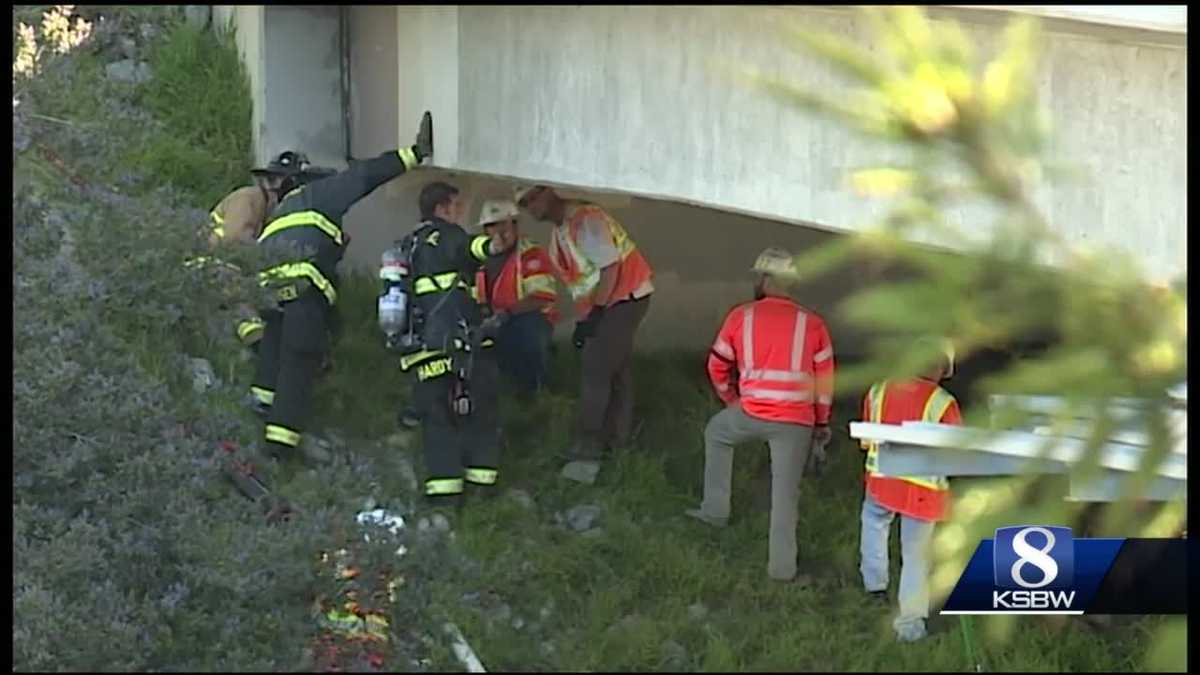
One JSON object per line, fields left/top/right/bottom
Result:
{"left": 991, "top": 525, "right": 1079, "bottom": 614}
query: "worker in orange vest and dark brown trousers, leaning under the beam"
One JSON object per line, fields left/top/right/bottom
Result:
{"left": 514, "top": 185, "right": 654, "bottom": 460}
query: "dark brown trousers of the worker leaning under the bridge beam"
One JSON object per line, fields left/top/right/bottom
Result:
{"left": 578, "top": 295, "right": 650, "bottom": 450}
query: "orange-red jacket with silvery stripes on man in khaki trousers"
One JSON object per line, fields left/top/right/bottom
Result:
{"left": 708, "top": 297, "right": 834, "bottom": 426}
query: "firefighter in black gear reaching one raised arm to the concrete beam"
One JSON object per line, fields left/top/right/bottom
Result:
{"left": 251, "top": 113, "right": 433, "bottom": 459}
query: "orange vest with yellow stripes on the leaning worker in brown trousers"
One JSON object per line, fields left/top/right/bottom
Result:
{"left": 550, "top": 202, "right": 654, "bottom": 317}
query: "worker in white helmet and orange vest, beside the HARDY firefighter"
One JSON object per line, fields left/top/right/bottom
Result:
{"left": 473, "top": 199, "right": 558, "bottom": 394}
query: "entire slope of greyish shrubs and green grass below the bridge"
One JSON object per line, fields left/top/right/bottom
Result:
{"left": 13, "top": 7, "right": 1171, "bottom": 671}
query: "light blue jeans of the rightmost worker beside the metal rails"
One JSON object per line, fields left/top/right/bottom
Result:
{"left": 859, "top": 492, "right": 935, "bottom": 640}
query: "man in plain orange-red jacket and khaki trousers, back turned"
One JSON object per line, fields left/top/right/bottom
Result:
{"left": 686, "top": 249, "right": 834, "bottom": 584}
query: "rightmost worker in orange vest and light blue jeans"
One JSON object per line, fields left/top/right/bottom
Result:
{"left": 859, "top": 339, "right": 962, "bottom": 641}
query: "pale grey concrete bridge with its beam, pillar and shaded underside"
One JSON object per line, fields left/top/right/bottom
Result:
{"left": 218, "top": 6, "right": 1187, "bottom": 353}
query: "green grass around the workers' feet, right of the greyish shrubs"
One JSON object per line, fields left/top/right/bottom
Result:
{"left": 294, "top": 271, "right": 1156, "bottom": 671}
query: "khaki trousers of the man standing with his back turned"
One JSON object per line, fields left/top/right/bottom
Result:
{"left": 700, "top": 405, "right": 812, "bottom": 580}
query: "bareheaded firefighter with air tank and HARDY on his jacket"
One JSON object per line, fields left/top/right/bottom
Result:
{"left": 400, "top": 183, "right": 500, "bottom": 506}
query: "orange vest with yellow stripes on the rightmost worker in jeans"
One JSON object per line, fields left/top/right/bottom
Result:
{"left": 862, "top": 378, "right": 962, "bottom": 520}
